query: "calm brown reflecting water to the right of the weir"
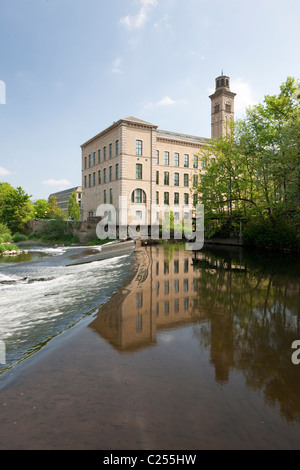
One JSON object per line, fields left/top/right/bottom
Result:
{"left": 0, "top": 245, "right": 300, "bottom": 450}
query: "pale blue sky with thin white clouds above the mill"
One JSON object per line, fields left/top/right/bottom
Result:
{"left": 0, "top": 0, "right": 300, "bottom": 200}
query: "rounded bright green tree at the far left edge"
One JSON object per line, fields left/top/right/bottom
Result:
{"left": 0, "top": 183, "right": 34, "bottom": 233}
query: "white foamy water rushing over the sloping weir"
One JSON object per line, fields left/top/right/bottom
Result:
{"left": 0, "top": 247, "right": 135, "bottom": 372}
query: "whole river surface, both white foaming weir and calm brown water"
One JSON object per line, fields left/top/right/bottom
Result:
{"left": 0, "top": 244, "right": 300, "bottom": 449}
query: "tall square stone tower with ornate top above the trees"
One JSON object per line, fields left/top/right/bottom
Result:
{"left": 210, "top": 72, "right": 236, "bottom": 140}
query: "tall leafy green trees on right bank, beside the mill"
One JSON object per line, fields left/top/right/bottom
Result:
{"left": 193, "top": 77, "right": 300, "bottom": 250}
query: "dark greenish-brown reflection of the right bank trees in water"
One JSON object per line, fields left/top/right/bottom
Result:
{"left": 194, "top": 250, "right": 300, "bottom": 421}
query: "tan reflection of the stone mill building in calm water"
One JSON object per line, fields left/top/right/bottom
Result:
{"left": 90, "top": 245, "right": 204, "bottom": 352}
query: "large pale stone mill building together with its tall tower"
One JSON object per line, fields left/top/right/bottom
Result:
{"left": 81, "top": 74, "right": 236, "bottom": 225}
